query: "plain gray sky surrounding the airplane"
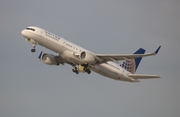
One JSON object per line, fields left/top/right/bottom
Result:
{"left": 0, "top": 0, "right": 180, "bottom": 117}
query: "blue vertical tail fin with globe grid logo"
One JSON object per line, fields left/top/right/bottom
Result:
{"left": 120, "top": 48, "right": 145, "bottom": 74}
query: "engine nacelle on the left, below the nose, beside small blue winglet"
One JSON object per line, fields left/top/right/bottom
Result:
{"left": 41, "top": 53, "right": 59, "bottom": 65}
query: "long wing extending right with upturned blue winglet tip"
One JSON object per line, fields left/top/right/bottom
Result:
{"left": 96, "top": 46, "right": 161, "bottom": 62}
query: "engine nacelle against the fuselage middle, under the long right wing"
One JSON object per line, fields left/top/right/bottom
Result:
{"left": 79, "top": 51, "right": 96, "bottom": 64}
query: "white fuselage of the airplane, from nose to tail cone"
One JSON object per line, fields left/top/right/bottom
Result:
{"left": 22, "top": 27, "right": 137, "bottom": 82}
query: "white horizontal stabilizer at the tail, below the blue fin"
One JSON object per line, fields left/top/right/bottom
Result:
{"left": 128, "top": 74, "right": 160, "bottom": 79}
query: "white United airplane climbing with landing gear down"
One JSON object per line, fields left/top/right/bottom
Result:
{"left": 21, "top": 26, "right": 161, "bottom": 82}
